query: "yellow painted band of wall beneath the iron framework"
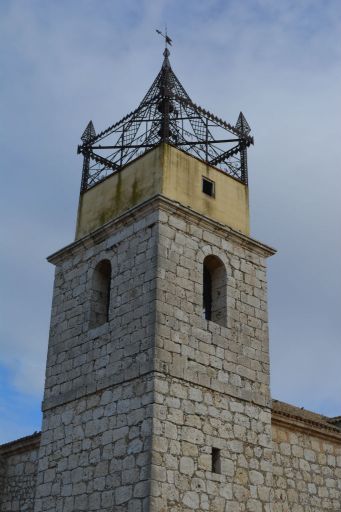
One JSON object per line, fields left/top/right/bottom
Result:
{"left": 76, "top": 144, "right": 250, "bottom": 239}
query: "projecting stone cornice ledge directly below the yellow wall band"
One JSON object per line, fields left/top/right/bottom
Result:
{"left": 47, "top": 194, "right": 277, "bottom": 265}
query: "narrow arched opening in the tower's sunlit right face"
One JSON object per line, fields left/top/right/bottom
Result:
{"left": 203, "top": 255, "right": 227, "bottom": 326}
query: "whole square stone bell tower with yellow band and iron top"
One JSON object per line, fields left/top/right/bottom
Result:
{"left": 34, "top": 48, "right": 273, "bottom": 512}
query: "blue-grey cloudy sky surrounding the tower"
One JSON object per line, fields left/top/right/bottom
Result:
{"left": 0, "top": 0, "right": 341, "bottom": 443}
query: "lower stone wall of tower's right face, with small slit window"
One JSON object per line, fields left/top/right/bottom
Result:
{"left": 150, "top": 375, "right": 272, "bottom": 512}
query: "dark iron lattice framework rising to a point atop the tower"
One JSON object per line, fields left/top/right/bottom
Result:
{"left": 78, "top": 48, "right": 253, "bottom": 192}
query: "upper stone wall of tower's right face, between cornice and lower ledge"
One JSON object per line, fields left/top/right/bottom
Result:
{"left": 155, "top": 209, "right": 270, "bottom": 407}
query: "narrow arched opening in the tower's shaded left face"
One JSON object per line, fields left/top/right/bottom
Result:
{"left": 90, "top": 260, "right": 111, "bottom": 328}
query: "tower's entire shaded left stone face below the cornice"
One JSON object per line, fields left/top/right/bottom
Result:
{"left": 34, "top": 206, "right": 157, "bottom": 512}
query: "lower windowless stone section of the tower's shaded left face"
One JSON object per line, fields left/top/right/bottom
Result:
{"left": 34, "top": 377, "right": 153, "bottom": 512}
